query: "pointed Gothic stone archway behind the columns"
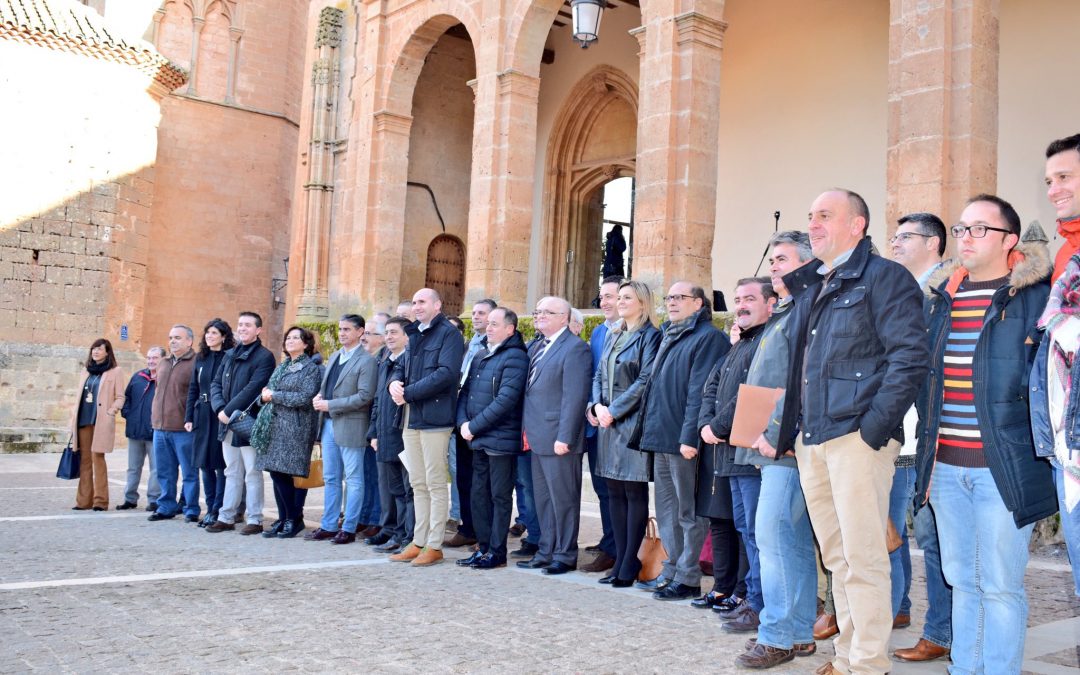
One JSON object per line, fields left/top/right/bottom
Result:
{"left": 540, "top": 66, "right": 637, "bottom": 307}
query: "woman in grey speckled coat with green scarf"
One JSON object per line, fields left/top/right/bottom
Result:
{"left": 252, "top": 326, "right": 322, "bottom": 539}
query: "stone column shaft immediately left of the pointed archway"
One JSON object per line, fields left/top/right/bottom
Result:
{"left": 464, "top": 64, "right": 540, "bottom": 310}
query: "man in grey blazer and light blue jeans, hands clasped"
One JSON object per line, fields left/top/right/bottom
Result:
{"left": 305, "top": 314, "right": 379, "bottom": 544}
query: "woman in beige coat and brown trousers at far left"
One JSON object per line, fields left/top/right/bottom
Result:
{"left": 71, "top": 338, "right": 125, "bottom": 511}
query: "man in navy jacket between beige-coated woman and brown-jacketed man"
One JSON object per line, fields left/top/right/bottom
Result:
{"left": 117, "top": 347, "right": 165, "bottom": 512}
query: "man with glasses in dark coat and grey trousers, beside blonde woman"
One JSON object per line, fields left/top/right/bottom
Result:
{"left": 627, "top": 281, "right": 731, "bottom": 600}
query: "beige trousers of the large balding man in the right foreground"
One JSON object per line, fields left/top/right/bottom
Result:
{"left": 795, "top": 431, "right": 900, "bottom": 673}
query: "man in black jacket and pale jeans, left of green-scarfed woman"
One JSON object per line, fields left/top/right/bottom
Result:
{"left": 206, "top": 312, "right": 275, "bottom": 535}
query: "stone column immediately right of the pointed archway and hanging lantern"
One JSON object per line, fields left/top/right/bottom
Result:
{"left": 632, "top": 0, "right": 727, "bottom": 293}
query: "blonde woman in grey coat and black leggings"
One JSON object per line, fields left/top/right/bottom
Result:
{"left": 590, "top": 281, "right": 660, "bottom": 588}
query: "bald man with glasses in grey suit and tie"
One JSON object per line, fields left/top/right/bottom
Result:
{"left": 517, "top": 297, "right": 593, "bottom": 575}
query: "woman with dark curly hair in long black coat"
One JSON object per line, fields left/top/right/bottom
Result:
{"left": 184, "top": 319, "right": 237, "bottom": 527}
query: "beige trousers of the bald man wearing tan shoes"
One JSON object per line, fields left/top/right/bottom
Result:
{"left": 399, "top": 405, "right": 453, "bottom": 551}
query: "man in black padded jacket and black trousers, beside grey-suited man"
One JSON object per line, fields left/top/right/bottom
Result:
{"left": 458, "top": 307, "right": 529, "bottom": 569}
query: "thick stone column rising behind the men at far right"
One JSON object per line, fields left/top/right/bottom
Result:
{"left": 886, "top": 0, "right": 999, "bottom": 232}
